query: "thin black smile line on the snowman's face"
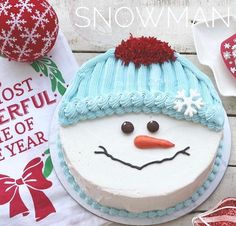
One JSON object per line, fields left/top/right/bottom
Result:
{"left": 94, "top": 146, "right": 190, "bottom": 170}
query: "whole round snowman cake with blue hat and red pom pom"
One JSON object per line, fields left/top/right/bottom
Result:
{"left": 59, "top": 36, "right": 224, "bottom": 216}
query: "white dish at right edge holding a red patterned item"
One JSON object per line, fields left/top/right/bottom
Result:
{"left": 192, "top": 16, "right": 236, "bottom": 97}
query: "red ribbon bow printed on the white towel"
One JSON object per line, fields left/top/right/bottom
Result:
{"left": 0, "top": 158, "right": 56, "bottom": 221}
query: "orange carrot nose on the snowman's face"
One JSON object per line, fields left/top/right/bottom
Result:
{"left": 134, "top": 136, "right": 175, "bottom": 149}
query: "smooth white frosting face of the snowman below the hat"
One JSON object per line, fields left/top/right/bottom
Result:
{"left": 60, "top": 113, "right": 222, "bottom": 211}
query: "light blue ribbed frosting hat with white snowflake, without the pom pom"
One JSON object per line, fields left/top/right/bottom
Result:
{"left": 59, "top": 36, "right": 224, "bottom": 131}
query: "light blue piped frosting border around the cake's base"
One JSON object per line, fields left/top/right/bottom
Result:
{"left": 57, "top": 138, "right": 223, "bottom": 218}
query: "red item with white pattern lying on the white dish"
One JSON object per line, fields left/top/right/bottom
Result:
{"left": 221, "top": 34, "right": 236, "bottom": 78}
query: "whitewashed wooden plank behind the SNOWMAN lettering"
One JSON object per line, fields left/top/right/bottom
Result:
{"left": 51, "top": 0, "right": 236, "bottom": 53}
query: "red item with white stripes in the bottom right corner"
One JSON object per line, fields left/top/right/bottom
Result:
{"left": 192, "top": 198, "right": 236, "bottom": 226}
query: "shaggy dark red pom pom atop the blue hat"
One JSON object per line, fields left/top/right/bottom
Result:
{"left": 115, "top": 35, "right": 176, "bottom": 67}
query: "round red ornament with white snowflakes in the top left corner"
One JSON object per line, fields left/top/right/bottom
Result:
{"left": 0, "top": 0, "right": 59, "bottom": 62}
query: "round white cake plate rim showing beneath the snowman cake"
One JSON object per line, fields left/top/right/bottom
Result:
{"left": 49, "top": 108, "right": 231, "bottom": 225}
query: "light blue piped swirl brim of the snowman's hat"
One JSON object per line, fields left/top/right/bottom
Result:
{"left": 59, "top": 92, "right": 224, "bottom": 131}
